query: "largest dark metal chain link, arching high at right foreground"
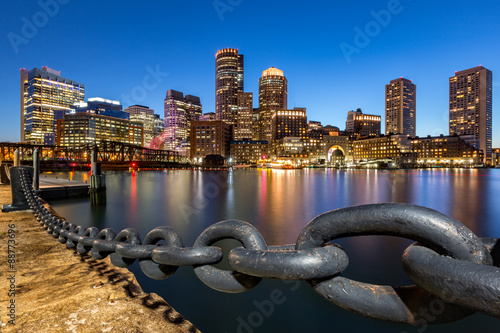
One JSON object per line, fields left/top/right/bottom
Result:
{"left": 297, "top": 203, "right": 492, "bottom": 324}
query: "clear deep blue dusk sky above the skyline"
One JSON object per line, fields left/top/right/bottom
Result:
{"left": 0, "top": 0, "right": 500, "bottom": 147}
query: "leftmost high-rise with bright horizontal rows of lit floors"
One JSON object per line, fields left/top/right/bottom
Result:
{"left": 21, "top": 67, "right": 85, "bottom": 144}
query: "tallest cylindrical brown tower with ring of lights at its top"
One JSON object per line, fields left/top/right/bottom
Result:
{"left": 215, "top": 48, "right": 244, "bottom": 125}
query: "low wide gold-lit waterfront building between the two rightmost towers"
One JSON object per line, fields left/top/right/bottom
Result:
{"left": 411, "top": 135, "right": 483, "bottom": 167}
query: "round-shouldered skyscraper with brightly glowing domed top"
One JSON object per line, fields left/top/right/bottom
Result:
{"left": 259, "top": 67, "right": 288, "bottom": 143}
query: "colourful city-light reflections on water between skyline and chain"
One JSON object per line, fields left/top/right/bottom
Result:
{"left": 48, "top": 169, "right": 500, "bottom": 244}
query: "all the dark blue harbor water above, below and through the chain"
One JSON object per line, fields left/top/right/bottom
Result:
{"left": 48, "top": 169, "right": 500, "bottom": 333}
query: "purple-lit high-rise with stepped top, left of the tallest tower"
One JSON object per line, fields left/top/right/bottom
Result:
{"left": 164, "top": 90, "right": 202, "bottom": 150}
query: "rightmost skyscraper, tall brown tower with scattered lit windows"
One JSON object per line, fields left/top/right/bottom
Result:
{"left": 450, "top": 66, "right": 493, "bottom": 163}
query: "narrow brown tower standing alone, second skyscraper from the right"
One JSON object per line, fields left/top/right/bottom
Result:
{"left": 385, "top": 77, "right": 417, "bottom": 137}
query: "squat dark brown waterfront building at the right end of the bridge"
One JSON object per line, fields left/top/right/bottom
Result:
{"left": 190, "top": 120, "right": 233, "bottom": 159}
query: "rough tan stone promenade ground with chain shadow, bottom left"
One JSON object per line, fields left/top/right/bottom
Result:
{"left": 0, "top": 185, "right": 199, "bottom": 333}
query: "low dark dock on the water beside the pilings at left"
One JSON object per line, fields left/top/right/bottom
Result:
{"left": 39, "top": 177, "right": 90, "bottom": 201}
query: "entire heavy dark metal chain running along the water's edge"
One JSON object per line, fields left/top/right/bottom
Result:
{"left": 17, "top": 169, "right": 500, "bottom": 324}
